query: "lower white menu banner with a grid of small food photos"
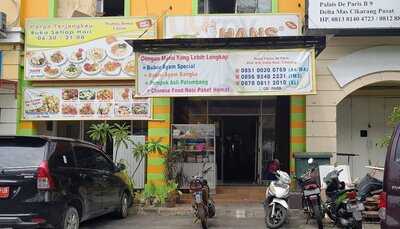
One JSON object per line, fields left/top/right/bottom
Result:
{"left": 23, "top": 87, "right": 152, "bottom": 120}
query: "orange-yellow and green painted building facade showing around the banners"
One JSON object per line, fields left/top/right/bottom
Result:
{"left": 13, "top": 0, "right": 306, "bottom": 193}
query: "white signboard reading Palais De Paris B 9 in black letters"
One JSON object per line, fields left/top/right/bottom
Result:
{"left": 308, "top": 0, "right": 400, "bottom": 29}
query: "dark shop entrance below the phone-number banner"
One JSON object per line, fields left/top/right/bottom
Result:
{"left": 173, "top": 96, "right": 290, "bottom": 184}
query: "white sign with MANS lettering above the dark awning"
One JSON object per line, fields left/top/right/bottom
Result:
{"left": 165, "top": 14, "right": 301, "bottom": 38}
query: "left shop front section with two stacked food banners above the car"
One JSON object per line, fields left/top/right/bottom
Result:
{"left": 22, "top": 17, "right": 156, "bottom": 157}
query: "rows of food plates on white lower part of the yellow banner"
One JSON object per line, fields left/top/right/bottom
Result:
{"left": 26, "top": 37, "right": 136, "bottom": 80}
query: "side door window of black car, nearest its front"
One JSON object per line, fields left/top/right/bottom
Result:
{"left": 74, "top": 146, "right": 113, "bottom": 171}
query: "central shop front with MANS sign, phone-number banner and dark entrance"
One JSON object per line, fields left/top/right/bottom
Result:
{"left": 131, "top": 12, "right": 325, "bottom": 187}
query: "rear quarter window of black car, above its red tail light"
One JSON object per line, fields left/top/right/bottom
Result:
{"left": 49, "top": 141, "right": 74, "bottom": 168}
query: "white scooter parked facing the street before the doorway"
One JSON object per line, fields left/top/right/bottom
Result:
{"left": 264, "top": 170, "right": 290, "bottom": 229}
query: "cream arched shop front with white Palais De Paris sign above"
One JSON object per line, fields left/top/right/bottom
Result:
{"left": 306, "top": 0, "right": 400, "bottom": 178}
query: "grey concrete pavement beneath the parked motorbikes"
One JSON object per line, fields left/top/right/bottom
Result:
{"left": 77, "top": 204, "right": 380, "bottom": 229}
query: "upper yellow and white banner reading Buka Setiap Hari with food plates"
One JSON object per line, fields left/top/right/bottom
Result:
{"left": 25, "top": 17, "right": 157, "bottom": 81}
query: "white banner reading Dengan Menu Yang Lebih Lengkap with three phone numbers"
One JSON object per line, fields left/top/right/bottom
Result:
{"left": 137, "top": 49, "right": 315, "bottom": 97}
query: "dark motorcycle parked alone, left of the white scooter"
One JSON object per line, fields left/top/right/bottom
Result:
{"left": 189, "top": 163, "right": 215, "bottom": 229}
